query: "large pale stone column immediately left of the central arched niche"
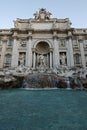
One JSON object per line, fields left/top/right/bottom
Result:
{"left": 26, "top": 33, "right": 32, "bottom": 68}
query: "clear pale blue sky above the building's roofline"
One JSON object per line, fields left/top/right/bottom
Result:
{"left": 0, "top": 0, "right": 87, "bottom": 29}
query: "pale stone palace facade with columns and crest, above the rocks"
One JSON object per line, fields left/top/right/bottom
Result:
{"left": 0, "top": 8, "right": 87, "bottom": 69}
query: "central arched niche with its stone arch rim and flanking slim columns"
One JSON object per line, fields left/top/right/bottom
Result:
{"left": 32, "top": 40, "right": 53, "bottom": 68}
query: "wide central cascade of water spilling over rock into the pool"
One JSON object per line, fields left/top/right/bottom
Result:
{"left": 22, "top": 73, "right": 59, "bottom": 88}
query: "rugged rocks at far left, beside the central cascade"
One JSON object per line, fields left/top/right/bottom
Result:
{"left": 0, "top": 69, "right": 24, "bottom": 89}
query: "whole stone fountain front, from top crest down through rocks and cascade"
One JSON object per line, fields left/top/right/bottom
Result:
{"left": 0, "top": 8, "right": 87, "bottom": 88}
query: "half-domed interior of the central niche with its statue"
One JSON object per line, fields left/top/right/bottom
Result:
{"left": 34, "top": 41, "right": 51, "bottom": 70}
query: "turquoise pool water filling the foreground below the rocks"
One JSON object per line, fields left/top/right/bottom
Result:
{"left": 0, "top": 89, "right": 87, "bottom": 130}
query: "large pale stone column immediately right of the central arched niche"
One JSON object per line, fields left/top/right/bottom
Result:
{"left": 53, "top": 31, "right": 59, "bottom": 67}
